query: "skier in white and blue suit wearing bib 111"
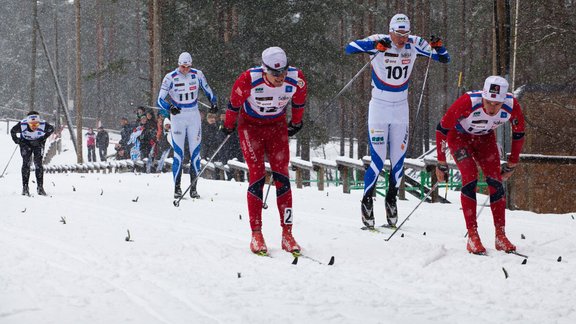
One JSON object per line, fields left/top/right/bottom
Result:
{"left": 158, "top": 52, "right": 218, "bottom": 198}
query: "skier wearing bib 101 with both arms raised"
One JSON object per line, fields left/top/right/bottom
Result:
{"left": 346, "top": 14, "right": 450, "bottom": 228}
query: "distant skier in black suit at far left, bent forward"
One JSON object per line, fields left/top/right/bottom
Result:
{"left": 10, "top": 110, "right": 54, "bottom": 196}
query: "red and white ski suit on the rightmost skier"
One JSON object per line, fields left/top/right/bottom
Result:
{"left": 436, "top": 91, "right": 524, "bottom": 230}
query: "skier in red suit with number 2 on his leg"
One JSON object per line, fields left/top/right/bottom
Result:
{"left": 222, "top": 47, "right": 306, "bottom": 254}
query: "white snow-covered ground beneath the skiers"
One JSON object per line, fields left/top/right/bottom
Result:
{"left": 0, "top": 123, "right": 576, "bottom": 324}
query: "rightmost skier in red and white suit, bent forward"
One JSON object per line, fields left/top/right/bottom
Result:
{"left": 436, "top": 76, "right": 524, "bottom": 254}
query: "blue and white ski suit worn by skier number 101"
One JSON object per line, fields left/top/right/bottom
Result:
{"left": 346, "top": 34, "right": 450, "bottom": 195}
